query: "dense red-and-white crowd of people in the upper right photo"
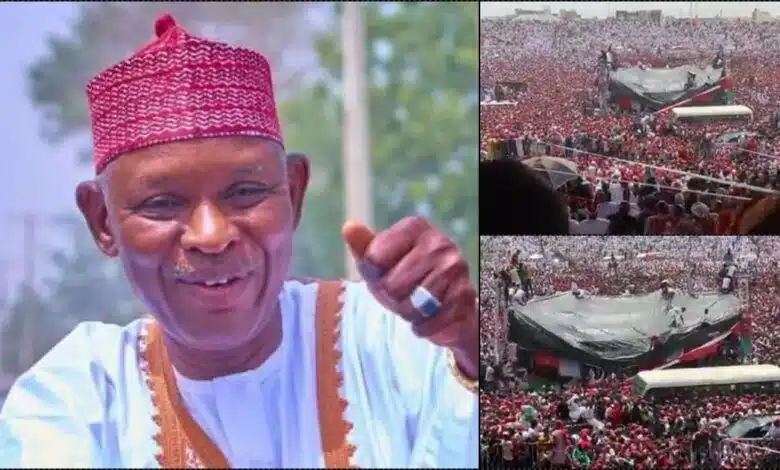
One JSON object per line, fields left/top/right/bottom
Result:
{"left": 480, "top": 18, "right": 780, "bottom": 235}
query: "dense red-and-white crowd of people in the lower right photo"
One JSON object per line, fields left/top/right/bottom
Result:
{"left": 480, "top": 236, "right": 780, "bottom": 469}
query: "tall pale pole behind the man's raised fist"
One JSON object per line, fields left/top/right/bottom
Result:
{"left": 341, "top": 2, "right": 373, "bottom": 280}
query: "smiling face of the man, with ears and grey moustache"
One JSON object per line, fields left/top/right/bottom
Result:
{"left": 77, "top": 137, "right": 308, "bottom": 350}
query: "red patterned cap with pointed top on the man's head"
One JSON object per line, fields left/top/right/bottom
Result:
{"left": 87, "top": 15, "right": 283, "bottom": 173}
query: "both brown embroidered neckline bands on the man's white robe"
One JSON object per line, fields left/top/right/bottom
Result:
{"left": 139, "top": 281, "right": 355, "bottom": 468}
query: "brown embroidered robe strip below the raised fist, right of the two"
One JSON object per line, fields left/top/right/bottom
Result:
{"left": 315, "top": 281, "right": 355, "bottom": 468}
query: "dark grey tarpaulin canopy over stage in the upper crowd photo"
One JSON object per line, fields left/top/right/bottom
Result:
{"left": 609, "top": 65, "right": 726, "bottom": 111}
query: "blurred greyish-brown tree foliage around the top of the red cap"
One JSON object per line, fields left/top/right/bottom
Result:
{"left": 28, "top": 2, "right": 316, "bottom": 145}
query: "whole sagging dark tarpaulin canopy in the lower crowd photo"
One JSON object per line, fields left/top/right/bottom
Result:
{"left": 509, "top": 290, "right": 740, "bottom": 369}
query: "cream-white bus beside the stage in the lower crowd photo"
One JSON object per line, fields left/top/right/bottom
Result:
{"left": 632, "top": 364, "right": 780, "bottom": 398}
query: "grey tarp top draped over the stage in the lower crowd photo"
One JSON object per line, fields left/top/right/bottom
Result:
{"left": 512, "top": 291, "right": 739, "bottom": 361}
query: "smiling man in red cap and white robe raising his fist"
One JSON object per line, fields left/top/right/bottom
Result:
{"left": 0, "top": 12, "right": 479, "bottom": 468}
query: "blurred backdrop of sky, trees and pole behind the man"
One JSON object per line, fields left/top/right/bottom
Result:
{"left": 0, "top": 2, "right": 478, "bottom": 402}
